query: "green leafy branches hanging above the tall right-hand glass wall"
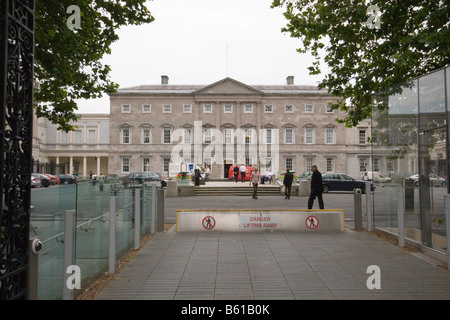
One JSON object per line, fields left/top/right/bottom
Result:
{"left": 272, "top": 0, "right": 450, "bottom": 127}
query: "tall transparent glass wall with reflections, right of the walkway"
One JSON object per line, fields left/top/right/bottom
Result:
{"left": 371, "top": 67, "right": 450, "bottom": 250}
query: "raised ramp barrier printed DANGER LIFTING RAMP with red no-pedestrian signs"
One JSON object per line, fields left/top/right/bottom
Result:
{"left": 176, "top": 209, "right": 345, "bottom": 232}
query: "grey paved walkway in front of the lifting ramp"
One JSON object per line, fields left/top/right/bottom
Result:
{"left": 97, "top": 228, "right": 450, "bottom": 300}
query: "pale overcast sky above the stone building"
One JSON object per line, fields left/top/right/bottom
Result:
{"left": 78, "top": 0, "right": 321, "bottom": 113}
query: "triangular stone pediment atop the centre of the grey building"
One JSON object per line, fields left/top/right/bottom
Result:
{"left": 193, "top": 78, "right": 262, "bottom": 95}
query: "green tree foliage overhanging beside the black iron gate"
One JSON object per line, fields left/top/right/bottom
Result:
{"left": 34, "top": 0, "right": 154, "bottom": 131}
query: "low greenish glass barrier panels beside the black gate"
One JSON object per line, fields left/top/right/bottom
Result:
{"left": 30, "top": 181, "right": 164, "bottom": 300}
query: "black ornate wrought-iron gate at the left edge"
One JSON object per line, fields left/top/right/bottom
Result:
{"left": 0, "top": 0, "right": 35, "bottom": 300}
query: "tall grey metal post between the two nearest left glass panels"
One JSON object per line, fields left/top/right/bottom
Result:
{"left": 63, "top": 210, "right": 75, "bottom": 300}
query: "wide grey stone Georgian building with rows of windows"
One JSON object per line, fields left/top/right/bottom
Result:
{"left": 34, "top": 76, "right": 371, "bottom": 179}
